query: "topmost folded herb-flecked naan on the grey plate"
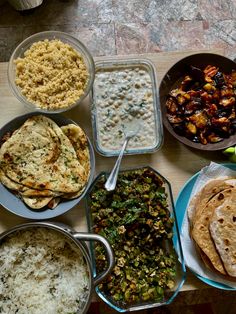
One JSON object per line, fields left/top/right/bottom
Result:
{"left": 0, "top": 115, "right": 86, "bottom": 193}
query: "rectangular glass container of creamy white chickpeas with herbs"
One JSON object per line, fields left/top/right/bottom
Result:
{"left": 91, "top": 59, "right": 163, "bottom": 156}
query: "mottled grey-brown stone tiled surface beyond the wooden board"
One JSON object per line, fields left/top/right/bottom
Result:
{"left": 0, "top": 0, "right": 236, "bottom": 61}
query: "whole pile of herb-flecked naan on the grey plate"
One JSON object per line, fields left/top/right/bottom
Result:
{"left": 0, "top": 115, "right": 90, "bottom": 209}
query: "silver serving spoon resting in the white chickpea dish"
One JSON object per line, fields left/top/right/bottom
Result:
{"left": 105, "top": 119, "right": 140, "bottom": 191}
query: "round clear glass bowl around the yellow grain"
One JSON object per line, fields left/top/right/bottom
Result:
{"left": 8, "top": 31, "right": 95, "bottom": 113}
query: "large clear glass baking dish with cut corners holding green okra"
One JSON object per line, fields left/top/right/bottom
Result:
{"left": 85, "top": 166, "right": 186, "bottom": 312}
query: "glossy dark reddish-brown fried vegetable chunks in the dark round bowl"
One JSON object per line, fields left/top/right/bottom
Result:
{"left": 166, "top": 64, "right": 236, "bottom": 145}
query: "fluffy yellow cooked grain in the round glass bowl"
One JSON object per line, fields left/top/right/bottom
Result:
{"left": 14, "top": 39, "right": 89, "bottom": 110}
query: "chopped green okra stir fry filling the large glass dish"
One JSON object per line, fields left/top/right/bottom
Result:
{"left": 90, "top": 168, "right": 176, "bottom": 306}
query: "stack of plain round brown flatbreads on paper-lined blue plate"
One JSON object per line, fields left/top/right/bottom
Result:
{"left": 188, "top": 178, "right": 236, "bottom": 279}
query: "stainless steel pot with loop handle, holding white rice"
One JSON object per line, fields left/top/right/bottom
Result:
{"left": 0, "top": 222, "right": 115, "bottom": 314}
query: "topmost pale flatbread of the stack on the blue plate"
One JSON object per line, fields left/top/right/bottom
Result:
{"left": 209, "top": 189, "right": 236, "bottom": 277}
